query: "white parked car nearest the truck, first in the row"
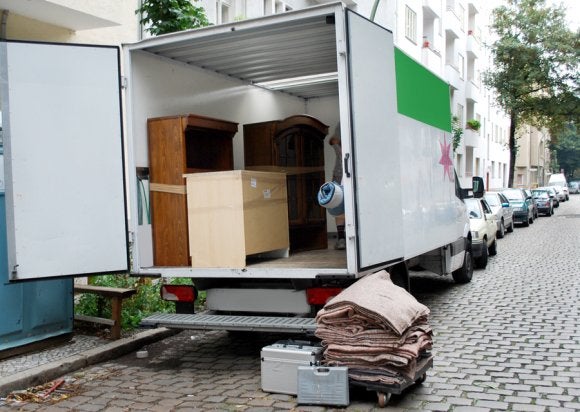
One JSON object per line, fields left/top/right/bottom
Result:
{"left": 465, "top": 198, "right": 497, "bottom": 269}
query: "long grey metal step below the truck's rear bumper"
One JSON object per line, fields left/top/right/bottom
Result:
{"left": 140, "top": 313, "right": 316, "bottom": 334}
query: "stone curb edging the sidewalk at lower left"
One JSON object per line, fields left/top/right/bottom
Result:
{"left": 0, "top": 328, "right": 180, "bottom": 396}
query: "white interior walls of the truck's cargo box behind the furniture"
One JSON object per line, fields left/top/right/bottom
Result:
{"left": 130, "top": 52, "right": 339, "bottom": 267}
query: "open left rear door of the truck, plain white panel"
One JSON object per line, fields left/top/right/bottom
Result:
{"left": 0, "top": 41, "right": 129, "bottom": 280}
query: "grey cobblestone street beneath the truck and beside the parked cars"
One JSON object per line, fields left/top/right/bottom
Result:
{"left": 0, "top": 195, "right": 580, "bottom": 412}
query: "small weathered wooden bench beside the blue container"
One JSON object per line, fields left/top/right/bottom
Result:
{"left": 74, "top": 284, "right": 137, "bottom": 339}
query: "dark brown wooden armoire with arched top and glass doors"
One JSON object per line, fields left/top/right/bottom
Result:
{"left": 244, "top": 115, "right": 328, "bottom": 252}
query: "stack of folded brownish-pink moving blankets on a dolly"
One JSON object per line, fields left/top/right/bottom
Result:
{"left": 315, "top": 270, "right": 433, "bottom": 385}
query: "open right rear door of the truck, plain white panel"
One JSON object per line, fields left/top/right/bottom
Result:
{"left": 345, "top": 10, "right": 404, "bottom": 273}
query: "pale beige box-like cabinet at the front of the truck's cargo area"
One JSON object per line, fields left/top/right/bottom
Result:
{"left": 185, "top": 170, "right": 289, "bottom": 268}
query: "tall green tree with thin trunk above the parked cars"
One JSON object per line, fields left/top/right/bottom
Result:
{"left": 484, "top": 0, "right": 580, "bottom": 186}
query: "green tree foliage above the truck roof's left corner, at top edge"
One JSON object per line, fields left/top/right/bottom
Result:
{"left": 135, "top": 0, "right": 210, "bottom": 36}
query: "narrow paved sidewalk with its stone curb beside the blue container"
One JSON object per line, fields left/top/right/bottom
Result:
{"left": 0, "top": 328, "right": 179, "bottom": 397}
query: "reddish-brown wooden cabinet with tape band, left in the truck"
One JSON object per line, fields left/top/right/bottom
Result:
{"left": 147, "top": 114, "right": 238, "bottom": 266}
